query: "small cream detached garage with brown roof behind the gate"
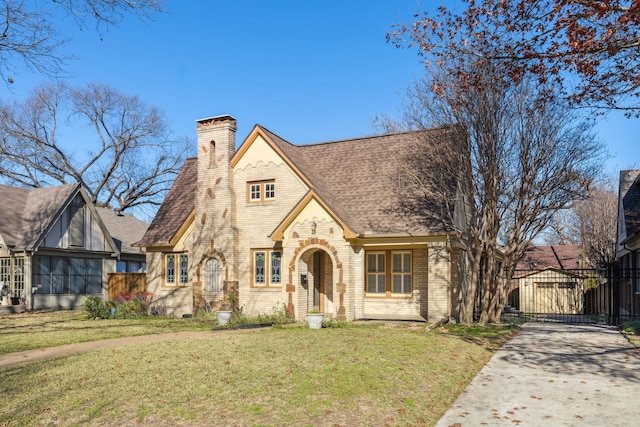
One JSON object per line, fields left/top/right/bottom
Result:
{"left": 509, "top": 245, "right": 585, "bottom": 314}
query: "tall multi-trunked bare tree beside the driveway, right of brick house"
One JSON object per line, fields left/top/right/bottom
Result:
{"left": 380, "top": 62, "right": 603, "bottom": 324}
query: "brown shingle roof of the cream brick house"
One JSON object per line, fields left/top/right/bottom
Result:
{"left": 138, "top": 125, "right": 459, "bottom": 246}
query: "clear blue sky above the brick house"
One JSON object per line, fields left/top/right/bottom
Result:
{"left": 9, "top": 0, "right": 640, "bottom": 177}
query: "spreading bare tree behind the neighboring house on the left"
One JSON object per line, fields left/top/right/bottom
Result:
{"left": 0, "top": 83, "right": 190, "bottom": 214}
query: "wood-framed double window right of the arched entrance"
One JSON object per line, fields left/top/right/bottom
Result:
{"left": 365, "top": 251, "right": 413, "bottom": 296}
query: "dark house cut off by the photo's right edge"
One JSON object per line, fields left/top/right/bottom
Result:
{"left": 616, "top": 170, "right": 640, "bottom": 318}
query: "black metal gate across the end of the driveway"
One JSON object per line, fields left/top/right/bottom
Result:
{"left": 503, "top": 267, "right": 620, "bottom": 324}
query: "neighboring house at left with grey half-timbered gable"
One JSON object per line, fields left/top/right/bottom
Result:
{"left": 0, "top": 184, "right": 147, "bottom": 309}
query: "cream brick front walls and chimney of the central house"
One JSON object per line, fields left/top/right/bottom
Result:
{"left": 141, "top": 116, "right": 454, "bottom": 321}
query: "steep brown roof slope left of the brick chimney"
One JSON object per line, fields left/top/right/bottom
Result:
{"left": 136, "top": 157, "right": 198, "bottom": 246}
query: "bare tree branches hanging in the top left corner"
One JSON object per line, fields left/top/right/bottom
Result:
{"left": 0, "top": 0, "right": 164, "bottom": 83}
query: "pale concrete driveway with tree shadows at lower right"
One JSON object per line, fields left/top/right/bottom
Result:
{"left": 436, "top": 323, "right": 640, "bottom": 427}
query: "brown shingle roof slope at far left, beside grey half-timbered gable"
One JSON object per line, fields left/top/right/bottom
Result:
{"left": 0, "top": 184, "right": 80, "bottom": 250}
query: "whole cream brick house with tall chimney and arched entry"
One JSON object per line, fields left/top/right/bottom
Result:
{"left": 138, "top": 116, "right": 460, "bottom": 320}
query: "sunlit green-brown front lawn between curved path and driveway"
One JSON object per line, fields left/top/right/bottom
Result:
{"left": 0, "top": 312, "right": 512, "bottom": 426}
